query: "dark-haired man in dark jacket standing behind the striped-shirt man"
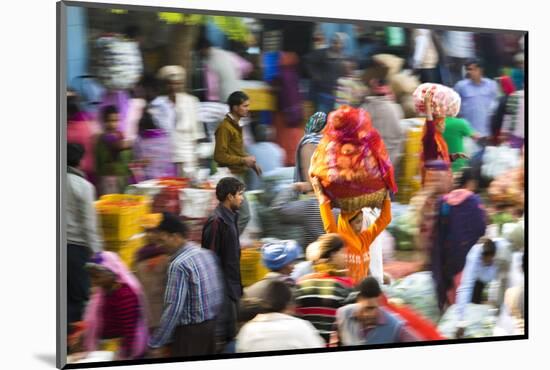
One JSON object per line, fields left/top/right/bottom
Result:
{"left": 201, "top": 177, "right": 244, "bottom": 351}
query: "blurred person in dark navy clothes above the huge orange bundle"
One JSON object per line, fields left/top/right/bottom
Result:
{"left": 306, "top": 32, "right": 347, "bottom": 114}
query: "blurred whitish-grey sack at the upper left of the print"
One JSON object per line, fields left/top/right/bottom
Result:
{"left": 93, "top": 34, "right": 143, "bottom": 90}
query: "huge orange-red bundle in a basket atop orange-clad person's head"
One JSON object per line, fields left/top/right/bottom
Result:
{"left": 310, "top": 106, "right": 397, "bottom": 212}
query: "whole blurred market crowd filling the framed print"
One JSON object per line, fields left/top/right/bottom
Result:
{"left": 66, "top": 10, "right": 526, "bottom": 362}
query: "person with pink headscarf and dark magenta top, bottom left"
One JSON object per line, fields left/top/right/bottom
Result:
{"left": 84, "top": 252, "right": 148, "bottom": 360}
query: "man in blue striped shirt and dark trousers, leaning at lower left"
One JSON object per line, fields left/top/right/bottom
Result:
{"left": 149, "top": 213, "right": 223, "bottom": 357}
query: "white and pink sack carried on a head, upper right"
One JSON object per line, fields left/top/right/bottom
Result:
{"left": 413, "top": 83, "right": 460, "bottom": 117}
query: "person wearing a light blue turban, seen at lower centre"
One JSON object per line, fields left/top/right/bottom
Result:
{"left": 244, "top": 240, "right": 301, "bottom": 298}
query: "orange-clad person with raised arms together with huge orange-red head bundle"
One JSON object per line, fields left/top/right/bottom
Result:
{"left": 310, "top": 106, "right": 397, "bottom": 282}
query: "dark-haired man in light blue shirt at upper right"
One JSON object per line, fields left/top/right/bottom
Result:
{"left": 454, "top": 59, "right": 498, "bottom": 137}
